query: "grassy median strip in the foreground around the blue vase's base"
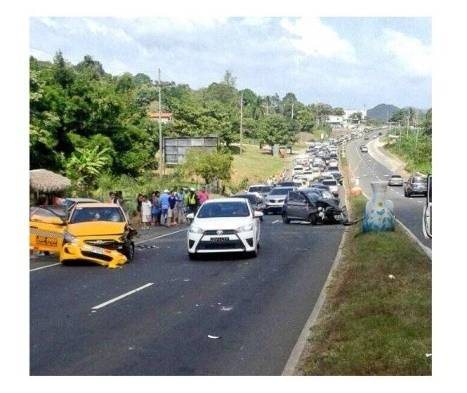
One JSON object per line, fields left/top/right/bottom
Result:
{"left": 300, "top": 196, "right": 432, "bottom": 375}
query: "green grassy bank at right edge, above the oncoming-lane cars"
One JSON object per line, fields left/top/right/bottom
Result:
{"left": 385, "top": 130, "right": 432, "bottom": 173}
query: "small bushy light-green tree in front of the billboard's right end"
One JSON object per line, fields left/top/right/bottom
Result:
{"left": 181, "top": 150, "right": 233, "bottom": 184}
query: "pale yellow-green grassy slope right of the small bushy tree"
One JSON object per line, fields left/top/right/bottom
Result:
{"left": 231, "top": 144, "right": 286, "bottom": 185}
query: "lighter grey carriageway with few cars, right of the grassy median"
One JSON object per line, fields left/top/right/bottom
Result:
{"left": 346, "top": 132, "right": 431, "bottom": 249}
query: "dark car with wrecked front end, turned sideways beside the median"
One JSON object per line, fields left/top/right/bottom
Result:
{"left": 282, "top": 189, "right": 345, "bottom": 225}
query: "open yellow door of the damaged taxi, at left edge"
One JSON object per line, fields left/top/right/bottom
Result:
{"left": 29, "top": 208, "right": 66, "bottom": 253}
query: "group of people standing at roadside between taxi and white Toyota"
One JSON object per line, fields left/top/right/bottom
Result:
{"left": 136, "top": 187, "right": 209, "bottom": 227}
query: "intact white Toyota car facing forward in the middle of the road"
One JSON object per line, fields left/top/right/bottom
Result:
{"left": 187, "top": 198, "right": 263, "bottom": 259}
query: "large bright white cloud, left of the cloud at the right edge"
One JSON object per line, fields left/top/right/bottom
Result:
{"left": 280, "top": 17, "right": 356, "bottom": 63}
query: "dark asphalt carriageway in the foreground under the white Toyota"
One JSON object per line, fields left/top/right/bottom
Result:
{"left": 30, "top": 216, "right": 343, "bottom": 375}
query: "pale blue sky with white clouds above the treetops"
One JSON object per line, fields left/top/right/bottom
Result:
{"left": 30, "top": 17, "right": 432, "bottom": 109}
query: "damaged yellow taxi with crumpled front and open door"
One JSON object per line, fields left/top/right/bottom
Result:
{"left": 29, "top": 203, "right": 136, "bottom": 267}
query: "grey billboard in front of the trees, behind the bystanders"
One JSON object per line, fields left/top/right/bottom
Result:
{"left": 164, "top": 136, "right": 218, "bottom": 165}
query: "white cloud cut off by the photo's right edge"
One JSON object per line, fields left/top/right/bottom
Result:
{"left": 383, "top": 29, "right": 431, "bottom": 76}
